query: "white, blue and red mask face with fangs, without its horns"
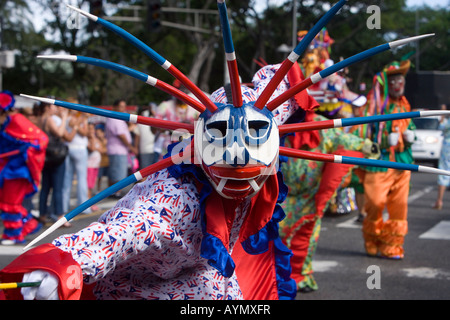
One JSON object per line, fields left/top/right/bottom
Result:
{"left": 194, "top": 103, "right": 279, "bottom": 198}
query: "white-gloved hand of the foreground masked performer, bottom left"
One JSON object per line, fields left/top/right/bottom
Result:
{"left": 20, "top": 270, "right": 59, "bottom": 300}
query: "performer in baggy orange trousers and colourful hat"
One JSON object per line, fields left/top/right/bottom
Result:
{"left": 363, "top": 60, "right": 415, "bottom": 259}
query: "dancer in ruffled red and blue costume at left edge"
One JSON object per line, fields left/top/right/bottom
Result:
{"left": 0, "top": 91, "right": 48, "bottom": 245}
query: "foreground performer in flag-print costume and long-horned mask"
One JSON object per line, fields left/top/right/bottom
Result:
{"left": 0, "top": 0, "right": 442, "bottom": 299}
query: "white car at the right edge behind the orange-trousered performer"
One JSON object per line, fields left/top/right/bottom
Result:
{"left": 411, "top": 116, "right": 444, "bottom": 166}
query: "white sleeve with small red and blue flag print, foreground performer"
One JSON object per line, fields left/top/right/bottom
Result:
{"left": 53, "top": 170, "right": 201, "bottom": 283}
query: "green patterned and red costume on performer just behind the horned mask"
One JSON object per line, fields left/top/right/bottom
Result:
{"left": 280, "top": 114, "right": 364, "bottom": 290}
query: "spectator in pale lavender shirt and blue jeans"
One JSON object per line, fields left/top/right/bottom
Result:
{"left": 105, "top": 100, "right": 137, "bottom": 198}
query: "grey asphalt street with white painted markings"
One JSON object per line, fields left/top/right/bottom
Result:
{"left": 0, "top": 164, "right": 450, "bottom": 303}
